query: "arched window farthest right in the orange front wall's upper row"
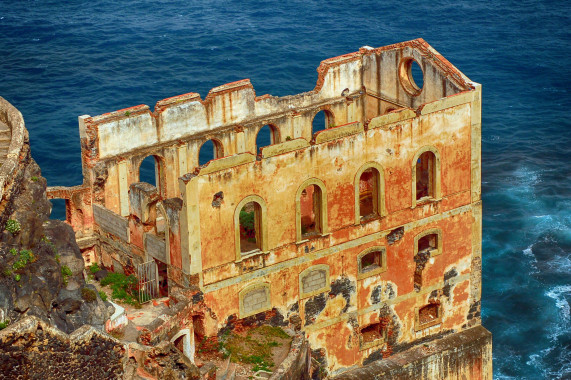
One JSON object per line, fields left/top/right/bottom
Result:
{"left": 412, "top": 146, "right": 441, "bottom": 208}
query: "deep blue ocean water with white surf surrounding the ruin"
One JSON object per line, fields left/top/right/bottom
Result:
{"left": 0, "top": 0, "right": 571, "bottom": 379}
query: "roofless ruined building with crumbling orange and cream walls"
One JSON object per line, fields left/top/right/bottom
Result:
{"left": 48, "top": 39, "right": 491, "bottom": 378}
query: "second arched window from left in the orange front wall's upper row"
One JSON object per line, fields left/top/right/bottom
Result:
{"left": 295, "top": 178, "right": 328, "bottom": 241}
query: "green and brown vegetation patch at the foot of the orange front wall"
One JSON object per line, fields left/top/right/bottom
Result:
{"left": 220, "top": 325, "right": 291, "bottom": 372}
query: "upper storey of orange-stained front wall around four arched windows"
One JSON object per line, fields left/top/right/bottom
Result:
{"left": 192, "top": 104, "right": 471, "bottom": 274}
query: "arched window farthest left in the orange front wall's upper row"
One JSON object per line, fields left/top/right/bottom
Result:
{"left": 234, "top": 195, "right": 268, "bottom": 260}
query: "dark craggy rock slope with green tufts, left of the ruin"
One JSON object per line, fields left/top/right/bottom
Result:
{"left": 0, "top": 142, "right": 110, "bottom": 333}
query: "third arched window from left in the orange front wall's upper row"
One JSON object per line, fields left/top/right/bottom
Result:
{"left": 355, "top": 162, "right": 386, "bottom": 224}
